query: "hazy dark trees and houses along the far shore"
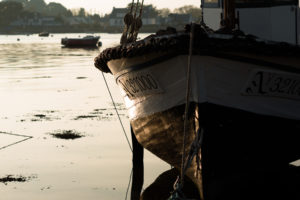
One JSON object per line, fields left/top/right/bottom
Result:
{"left": 0, "top": 0, "right": 201, "bottom": 33}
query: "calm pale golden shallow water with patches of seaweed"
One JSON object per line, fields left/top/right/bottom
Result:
{"left": 0, "top": 33, "right": 170, "bottom": 200}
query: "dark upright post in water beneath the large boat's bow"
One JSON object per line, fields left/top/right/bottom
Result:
{"left": 130, "top": 127, "right": 144, "bottom": 200}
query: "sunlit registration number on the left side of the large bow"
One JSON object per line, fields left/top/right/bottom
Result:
{"left": 116, "top": 71, "right": 163, "bottom": 99}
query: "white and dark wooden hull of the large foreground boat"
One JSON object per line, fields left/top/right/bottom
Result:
{"left": 108, "top": 53, "right": 300, "bottom": 197}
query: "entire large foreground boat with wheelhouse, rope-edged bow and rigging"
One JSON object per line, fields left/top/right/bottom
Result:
{"left": 95, "top": 0, "right": 300, "bottom": 200}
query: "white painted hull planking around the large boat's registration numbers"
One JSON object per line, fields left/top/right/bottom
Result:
{"left": 108, "top": 55, "right": 300, "bottom": 120}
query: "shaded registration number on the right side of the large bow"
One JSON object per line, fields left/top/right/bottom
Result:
{"left": 242, "top": 70, "right": 300, "bottom": 100}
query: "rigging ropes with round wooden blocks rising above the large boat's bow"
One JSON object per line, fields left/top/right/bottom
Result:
{"left": 120, "top": 0, "right": 144, "bottom": 45}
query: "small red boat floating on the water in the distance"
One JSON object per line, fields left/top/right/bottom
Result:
{"left": 61, "top": 35, "right": 100, "bottom": 47}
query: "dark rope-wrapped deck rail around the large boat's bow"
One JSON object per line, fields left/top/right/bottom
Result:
{"left": 94, "top": 25, "right": 300, "bottom": 73}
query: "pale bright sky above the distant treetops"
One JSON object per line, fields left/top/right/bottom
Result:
{"left": 45, "top": 0, "right": 201, "bottom": 15}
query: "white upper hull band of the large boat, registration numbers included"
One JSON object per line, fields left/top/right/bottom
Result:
{"left": 110, "top": 56, "right": 300, "bottom": 120}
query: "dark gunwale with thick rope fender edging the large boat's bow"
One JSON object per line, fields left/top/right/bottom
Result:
{"left": 94, "top": 24, "right": 300, "bottom": 73}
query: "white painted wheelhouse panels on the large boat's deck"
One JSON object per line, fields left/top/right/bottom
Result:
{"left": 204, "top": 5, "right": 300, "bottom": 44}
